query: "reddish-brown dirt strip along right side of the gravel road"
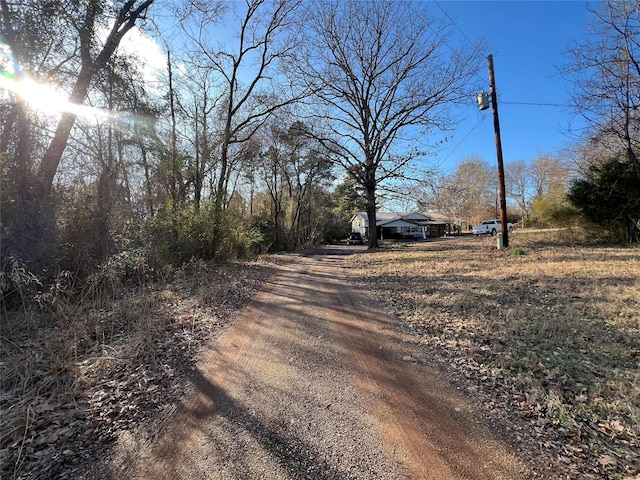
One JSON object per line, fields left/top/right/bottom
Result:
{"left": 310, "top": 253, "right": 529, "bottom": 480}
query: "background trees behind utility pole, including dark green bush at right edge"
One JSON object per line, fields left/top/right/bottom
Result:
{"left": 419, "top": 0, "right": 640, "bottom": 242}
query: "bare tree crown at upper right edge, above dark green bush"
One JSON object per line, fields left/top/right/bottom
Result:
{"left": 565, "top": 0, "right": 640, "bottom": 175}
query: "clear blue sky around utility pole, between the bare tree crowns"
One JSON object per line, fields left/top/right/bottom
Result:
{"left": 430, "top": 0, "right": 597, "bottom": 170}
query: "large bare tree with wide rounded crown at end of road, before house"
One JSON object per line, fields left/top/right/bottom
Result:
{"left": 298, "top": 0, "right": 480, "bottom": 248}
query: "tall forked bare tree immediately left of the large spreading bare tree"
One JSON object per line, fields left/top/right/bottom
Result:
{"left": 175, "top": 0, "right": 301, "bottom": 211}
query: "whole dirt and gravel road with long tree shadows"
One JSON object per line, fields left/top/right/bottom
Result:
{"left": 105, "top": 249, "right": 529, "bottom": 480}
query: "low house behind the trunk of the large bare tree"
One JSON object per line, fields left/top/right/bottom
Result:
{"left": 351, "top": 212, "right": 456, "bottom": 240}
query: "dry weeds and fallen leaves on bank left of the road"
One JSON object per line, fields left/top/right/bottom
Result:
{"left": 0, "top": 262, "right": 272, "bottom": 480}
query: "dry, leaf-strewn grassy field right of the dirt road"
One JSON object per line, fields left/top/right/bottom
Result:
{"left": 349, "top": 231, "right": 640, "bottom": 479}
